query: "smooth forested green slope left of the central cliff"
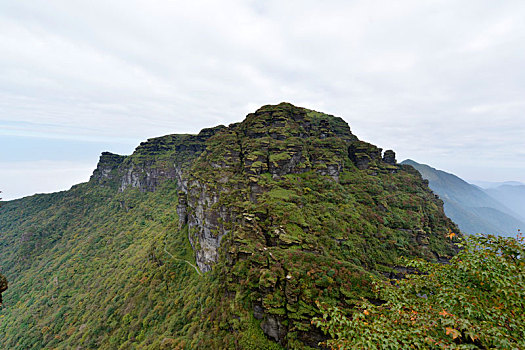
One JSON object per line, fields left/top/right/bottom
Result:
{"left": 0, "top": 182, "right": 219, "bottom": 349}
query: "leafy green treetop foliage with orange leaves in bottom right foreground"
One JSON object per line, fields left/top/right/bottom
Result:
{"left": 312, "top": 233, "right": 525, "bottom": 349}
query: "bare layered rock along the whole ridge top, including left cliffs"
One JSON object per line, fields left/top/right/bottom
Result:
{"left": 91, "top": 103, "right": 406, "bottom": 271}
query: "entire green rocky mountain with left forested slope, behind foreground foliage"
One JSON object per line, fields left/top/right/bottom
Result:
{"left": 0, "top": 103, "right": 458, "bottom": 349}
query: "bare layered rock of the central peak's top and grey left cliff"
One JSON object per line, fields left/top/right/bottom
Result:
{"left": 178, "top": 103, "right": 357, "bottom": 271}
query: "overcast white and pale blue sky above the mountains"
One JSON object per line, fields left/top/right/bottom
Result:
{"left": 0, "top": 0, "right": 525, "bottom": 199}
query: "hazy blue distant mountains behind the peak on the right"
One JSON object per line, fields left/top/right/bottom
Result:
{"left": 402, "top": 159, "right": 525, "bottom": 236}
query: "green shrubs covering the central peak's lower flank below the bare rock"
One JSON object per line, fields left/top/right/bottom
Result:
{"left": 191, "top": 167, "right": 453, "bottom": 348}
